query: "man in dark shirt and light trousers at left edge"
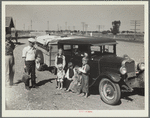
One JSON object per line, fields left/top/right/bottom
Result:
{"left": 5, "top": 34, "right": 15, "bottom": 87}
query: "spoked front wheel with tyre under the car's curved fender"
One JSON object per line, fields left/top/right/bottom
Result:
{"left": 99, "top": 78, "right": 121, "bottom": 105}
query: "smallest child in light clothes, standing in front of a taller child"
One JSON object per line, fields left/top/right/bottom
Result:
{"left": 57, "top": 64, "right": 65, "bottom": 89}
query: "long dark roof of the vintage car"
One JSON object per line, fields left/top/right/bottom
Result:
{"left": 58, "top": 36, "right": 117, "bottom": 46}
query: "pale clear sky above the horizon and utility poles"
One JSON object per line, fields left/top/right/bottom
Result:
{"left": 5, "top": 5, "right": 144, "bottom": 32}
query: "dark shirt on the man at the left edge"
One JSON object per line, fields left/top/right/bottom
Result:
{"left": 5, "top": 41, "right": 15, "bottom": 55}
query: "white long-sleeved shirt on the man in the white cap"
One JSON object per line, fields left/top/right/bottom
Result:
{"left": 22, "top": 46, "right": 36, "bottom": 61}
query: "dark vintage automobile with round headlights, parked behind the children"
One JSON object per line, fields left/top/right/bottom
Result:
{"left": 35, "top": 36, "right": 144, "bottom": 105}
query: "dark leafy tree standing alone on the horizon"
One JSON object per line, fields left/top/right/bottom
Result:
{"left": 111, "top": 21, "right": 121, "bottom": 38}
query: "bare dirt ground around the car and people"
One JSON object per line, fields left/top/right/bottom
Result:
{"left": 5, "top": 39, "right": 145, "bottom": 110}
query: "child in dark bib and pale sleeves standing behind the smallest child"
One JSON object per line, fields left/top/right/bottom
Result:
{"left": 55, "top": 48, "right": 66, "bottom": 88}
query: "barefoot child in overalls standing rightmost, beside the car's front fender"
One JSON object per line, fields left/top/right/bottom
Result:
{"left": 79, "top": 57, "right": 90, "bottom": 98}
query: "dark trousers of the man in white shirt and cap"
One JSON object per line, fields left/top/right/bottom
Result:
{"left": 25, "top": 61, "right": 36, "bottom": 86}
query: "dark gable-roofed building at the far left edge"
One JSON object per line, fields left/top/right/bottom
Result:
{"left": 5, "top": 17, "right": 15, "bottom": 34}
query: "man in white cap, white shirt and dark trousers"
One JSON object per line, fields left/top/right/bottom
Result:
{"left": 22, "top": 38, "right": 38, "bottom": 90}
